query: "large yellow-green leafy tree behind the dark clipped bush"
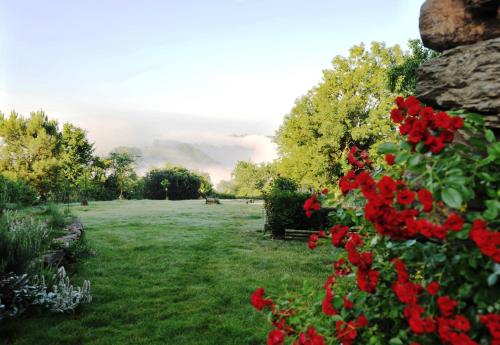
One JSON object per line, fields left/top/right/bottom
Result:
{"left": 275, "top": 42, "right": 403, "bottom": 188}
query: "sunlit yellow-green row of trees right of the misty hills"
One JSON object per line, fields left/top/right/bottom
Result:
{"left": 219, "top": 40, "right": 437, "bottom": 197}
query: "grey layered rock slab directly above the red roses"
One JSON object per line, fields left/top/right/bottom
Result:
{"left": 417, "top": 38, "right": 500, "bottom": 117}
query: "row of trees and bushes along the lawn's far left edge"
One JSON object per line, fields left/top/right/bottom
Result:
{"left": 0, "top": 111, "right": 212, "bottom": 204}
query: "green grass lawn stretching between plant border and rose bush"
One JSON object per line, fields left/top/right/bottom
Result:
{"left": 0, "top": 200, "right": 331, "bottom": 345}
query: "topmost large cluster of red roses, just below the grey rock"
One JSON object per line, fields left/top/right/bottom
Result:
{"left": 391, "top": 96, "right": 463, "bottom": 154}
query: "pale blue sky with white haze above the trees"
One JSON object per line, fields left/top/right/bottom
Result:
{"left": 0, "top": 0, "right": 423, "bottom": 159}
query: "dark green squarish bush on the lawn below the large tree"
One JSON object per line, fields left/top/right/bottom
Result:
{"left": 264, "top": 190, "right": 328, "bottom": 237}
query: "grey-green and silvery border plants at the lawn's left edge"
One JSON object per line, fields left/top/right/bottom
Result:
{"left": 0, "top": 205, "right": 91, "bottom": 321}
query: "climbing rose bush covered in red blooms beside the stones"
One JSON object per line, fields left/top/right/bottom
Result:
{"left": 251, "top": 96, "right": 500, "bottom": 345}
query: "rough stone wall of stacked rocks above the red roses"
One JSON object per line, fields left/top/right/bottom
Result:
{"left": 417, "top": 0, "right": 500, "bottom": 128}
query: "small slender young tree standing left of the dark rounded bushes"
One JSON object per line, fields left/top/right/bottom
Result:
{"left": 108, "top": 150, "right": 138, "bottom": 200}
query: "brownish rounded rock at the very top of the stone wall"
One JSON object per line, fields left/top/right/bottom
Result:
{"left": 419, "top": 0, "right": 500, "bottom": 51}
